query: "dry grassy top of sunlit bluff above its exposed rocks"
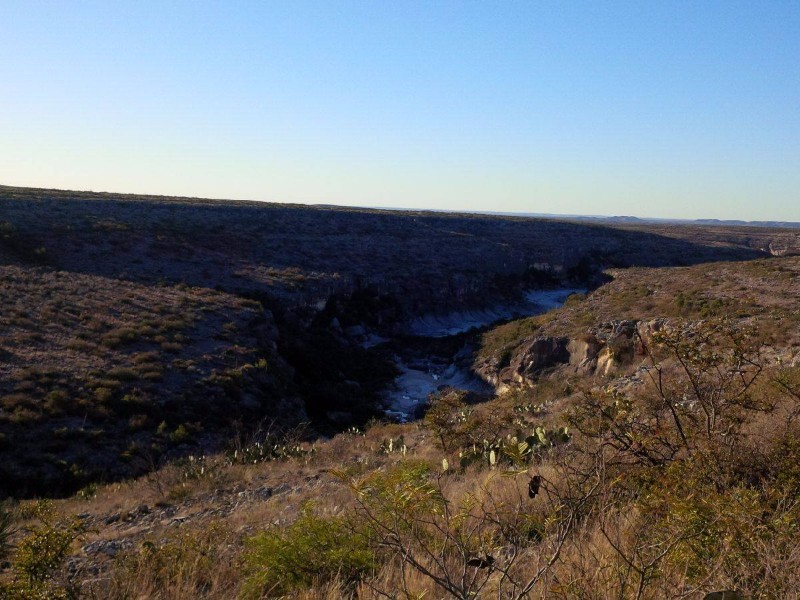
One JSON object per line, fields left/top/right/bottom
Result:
{"left": 474, "top": 257, "right": 800, "bottom": 389}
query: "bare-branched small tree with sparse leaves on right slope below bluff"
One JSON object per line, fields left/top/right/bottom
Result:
{"left": 569, "top": 320, "right": 771, "bottom": 467}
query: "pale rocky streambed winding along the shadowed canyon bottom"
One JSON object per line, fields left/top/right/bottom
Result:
{"left": 385, "top": 288, "right": 586, "bottom": 421}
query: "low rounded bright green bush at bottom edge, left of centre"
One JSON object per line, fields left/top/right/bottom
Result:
{"left": 245, "top": 506, "right": 376, "bottom": 598}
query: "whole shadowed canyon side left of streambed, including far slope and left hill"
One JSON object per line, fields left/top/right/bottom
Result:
{"left": 0, "top": 187, "right": 797, "bottom": 495}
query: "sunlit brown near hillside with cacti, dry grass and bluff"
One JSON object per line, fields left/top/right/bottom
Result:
{"left": 0, "top": 258, "right": 800, "bottom": 599}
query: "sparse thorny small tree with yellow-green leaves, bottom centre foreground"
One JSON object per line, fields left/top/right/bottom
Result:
{"left": 339, "top": 461, "right": 594, "bottom": 600}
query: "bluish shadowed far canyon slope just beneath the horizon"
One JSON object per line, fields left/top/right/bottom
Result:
{"left": 0, "top": 188, "right": 780, "bottom": 324}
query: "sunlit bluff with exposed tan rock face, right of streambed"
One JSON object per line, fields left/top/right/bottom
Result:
{"left": 474, "top": 259, "right": 800, "bottom": 388}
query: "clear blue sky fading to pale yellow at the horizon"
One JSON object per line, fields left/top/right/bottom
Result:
{"left": 0, "top": 0, "right": 800, "bottom": 221}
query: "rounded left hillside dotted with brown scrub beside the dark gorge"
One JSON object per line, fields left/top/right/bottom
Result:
{"left": 0, "top": 266, "right": 299, "bottom": 495}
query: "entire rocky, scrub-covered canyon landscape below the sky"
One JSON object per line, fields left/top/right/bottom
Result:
{"left": 0, "top": 188, "right": 800, "bottom": 599}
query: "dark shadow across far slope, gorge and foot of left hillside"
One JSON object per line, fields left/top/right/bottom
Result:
{"left": 0, "top": 187, "right": 792, "bottom": 495}
